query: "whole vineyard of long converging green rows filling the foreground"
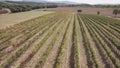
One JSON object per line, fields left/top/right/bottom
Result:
{"left": 0, "top": 12, "right": 120, "bottom": 68}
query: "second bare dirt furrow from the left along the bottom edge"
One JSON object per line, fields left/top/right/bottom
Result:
{"left": 25, "top": 16, "right": 66, "bottom": 68}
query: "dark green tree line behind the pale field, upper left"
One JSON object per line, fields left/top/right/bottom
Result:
{"left": 0, "top": 3, "right": 57, "bottom": 13}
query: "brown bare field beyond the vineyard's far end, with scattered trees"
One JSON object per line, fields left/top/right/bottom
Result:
{"left": 45, "top": 7, "right": 120, "bottom": 17}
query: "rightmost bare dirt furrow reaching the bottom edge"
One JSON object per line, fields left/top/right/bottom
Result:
{"left": 80, "top": 17, "right": 105, "bottom": 68}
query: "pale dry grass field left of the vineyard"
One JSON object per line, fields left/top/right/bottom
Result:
{"left": 0, "top": 10, "right": 53, "bottom": 28}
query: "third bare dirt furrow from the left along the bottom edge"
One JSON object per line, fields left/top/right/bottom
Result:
{"left": 42, "top": 15, "right": 71, "bottom": 68}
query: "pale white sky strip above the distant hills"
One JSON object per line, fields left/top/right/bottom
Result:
{"left": 4, "top": 0, "right": 120, "bottom": 4}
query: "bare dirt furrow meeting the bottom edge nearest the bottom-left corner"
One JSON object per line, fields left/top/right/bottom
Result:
{"left": 10, "top": 16, "right": 64, "bottom": 68}
